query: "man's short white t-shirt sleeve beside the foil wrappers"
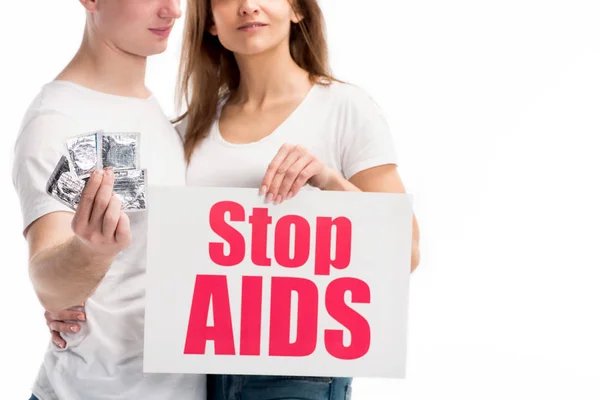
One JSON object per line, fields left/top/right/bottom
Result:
{"left": 12, "top": 112, "right": 78, "bottom": 231}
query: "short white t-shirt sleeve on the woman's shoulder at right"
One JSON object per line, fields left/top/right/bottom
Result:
{"left": 340, "top": 92, "right": 398, "bottom": 179}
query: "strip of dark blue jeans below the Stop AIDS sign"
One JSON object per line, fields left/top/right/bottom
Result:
{"left": 207, "top": 375, "right": 352, "bottom": 400}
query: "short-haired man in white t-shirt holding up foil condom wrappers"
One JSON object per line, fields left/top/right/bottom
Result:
{"left": 13, "top": 0, "right": 206, "bottom": 400}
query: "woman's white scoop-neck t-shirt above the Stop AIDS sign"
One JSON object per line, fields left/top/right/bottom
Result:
{"left": 177, "top": 81, "right": 397, "bottom": 190}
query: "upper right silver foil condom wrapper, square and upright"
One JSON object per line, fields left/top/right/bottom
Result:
{"left": 101, "top": 132, "right": 140, "bottom": 171}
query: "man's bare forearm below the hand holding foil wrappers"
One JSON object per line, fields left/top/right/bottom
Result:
{"left": 29, "top": 236, "right": 113, "bottom": 312}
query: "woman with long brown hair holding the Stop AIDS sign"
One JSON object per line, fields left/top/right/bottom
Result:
{"left": 48, "top": 0, "right": 419, "bottom": 400}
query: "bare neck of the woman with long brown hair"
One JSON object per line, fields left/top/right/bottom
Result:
{"left": 232, "top": 42, "right": 312, "bottom": 108}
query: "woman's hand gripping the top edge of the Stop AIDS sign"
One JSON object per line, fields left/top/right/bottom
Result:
{"left": 260, "top": 144, "right": 335, "bottom": 204}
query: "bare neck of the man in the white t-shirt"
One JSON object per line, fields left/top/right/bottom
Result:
{"left": 56, "top": 29, "right": 151, "bottom": 99}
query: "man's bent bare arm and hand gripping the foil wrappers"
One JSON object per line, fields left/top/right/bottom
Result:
{"left": 25, "top": 171, "right": 131, "bottom": 312}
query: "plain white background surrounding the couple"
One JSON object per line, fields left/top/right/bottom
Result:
{"left": 0, "top": 0, "right": 600, "bottom": 400}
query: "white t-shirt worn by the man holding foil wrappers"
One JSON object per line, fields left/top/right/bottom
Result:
{"left": 13, "top": 81, "right": 206, "bottom": 400}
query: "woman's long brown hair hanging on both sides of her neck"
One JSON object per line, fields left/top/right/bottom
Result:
{"left": 173, "top": 0, "right": 336, "bottom": 163}
